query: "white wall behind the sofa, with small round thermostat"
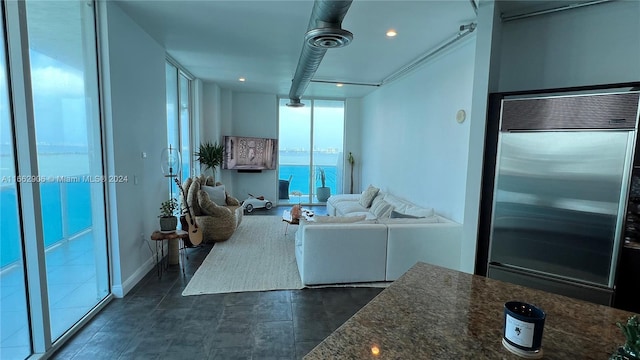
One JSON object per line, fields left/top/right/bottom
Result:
{"left": 360, "top": 35, "right": 475, "bottom": 223}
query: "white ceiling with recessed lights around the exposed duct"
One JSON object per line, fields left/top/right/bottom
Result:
{"left": 115, "top": 0, "right": 596, "bottom": 98}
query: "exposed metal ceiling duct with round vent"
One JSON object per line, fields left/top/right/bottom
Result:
{"left": 287, "top": 0, "right": 353, "bottom": 107}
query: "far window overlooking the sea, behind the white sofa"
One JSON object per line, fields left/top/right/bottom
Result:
{"left": 278, "top": 99, "right": 344, "bottom": 203}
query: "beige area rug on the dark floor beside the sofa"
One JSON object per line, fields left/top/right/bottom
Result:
{"left": 182, "top": 215, "right": 389, "bottom": 296}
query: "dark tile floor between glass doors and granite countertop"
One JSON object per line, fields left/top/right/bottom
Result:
{"left": 51, "top": 209, "right": 382, "bottom": 360}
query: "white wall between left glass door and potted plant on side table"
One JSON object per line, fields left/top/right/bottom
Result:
{"left": 100, "top": 2, "right": 169, "bottom": 296}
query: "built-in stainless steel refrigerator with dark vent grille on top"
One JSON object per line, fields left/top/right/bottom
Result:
{"left": 487, "top": 92, "right": 640, "bottom": 304}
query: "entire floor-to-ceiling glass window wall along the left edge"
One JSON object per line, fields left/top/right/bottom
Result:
{"left": 0, "top": 1, "right": 109, "bottom": 359}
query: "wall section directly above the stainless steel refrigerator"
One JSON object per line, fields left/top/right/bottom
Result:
{"left": 499, "top": 1, "right": 640, "bottom": 91}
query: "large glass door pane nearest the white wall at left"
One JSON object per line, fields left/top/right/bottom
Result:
{"left": 26, "top": 1, "right": 109, "bottom": 339}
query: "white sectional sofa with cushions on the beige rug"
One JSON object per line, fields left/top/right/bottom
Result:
{"left": 296, "top": 187, "right": 462, "bottom": 285}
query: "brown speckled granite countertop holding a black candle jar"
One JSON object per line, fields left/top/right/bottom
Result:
{"left": 304, "top": 263, "right": 633, "bottom": 360}
